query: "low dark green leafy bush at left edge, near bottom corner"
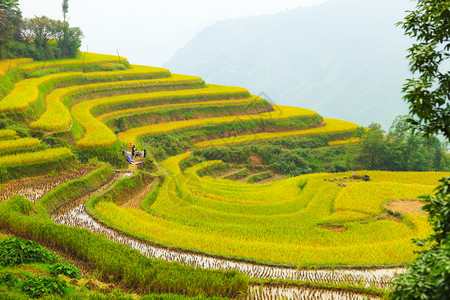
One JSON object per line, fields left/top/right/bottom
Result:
{"left": 0, "top": 237, "right": 58, "bottom": 266}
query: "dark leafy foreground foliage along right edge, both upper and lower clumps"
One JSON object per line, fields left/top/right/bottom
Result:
{"left": 391, "top": 0, "right": 450, "bottom": 299}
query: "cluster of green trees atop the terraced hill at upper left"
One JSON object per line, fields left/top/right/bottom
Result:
{"left": 0, "top": 0, "right": 83, "bottom": 60}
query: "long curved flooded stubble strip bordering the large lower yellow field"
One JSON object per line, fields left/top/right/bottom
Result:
{"left": 55, "top": 204, "right": 404, "bottom": 288}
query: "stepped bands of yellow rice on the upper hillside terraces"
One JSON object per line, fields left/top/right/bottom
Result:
{"left": 0, "top": 54, "right": 356, "bottom": 152}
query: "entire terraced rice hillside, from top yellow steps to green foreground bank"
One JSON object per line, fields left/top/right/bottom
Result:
{"left": 0, "top": 53, "right": 449, "bottom": 299}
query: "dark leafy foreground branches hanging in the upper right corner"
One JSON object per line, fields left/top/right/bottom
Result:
{"left": 399, "top": 0, "right": 450, "bottom": 139}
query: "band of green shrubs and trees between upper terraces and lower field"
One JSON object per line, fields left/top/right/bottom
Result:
{"left": 194, "top": 116, "right": 450, "bottom": 176}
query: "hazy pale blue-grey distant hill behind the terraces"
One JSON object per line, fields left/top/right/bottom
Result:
{"left": 165, "top": 0, "right": 412, "bottom": 127}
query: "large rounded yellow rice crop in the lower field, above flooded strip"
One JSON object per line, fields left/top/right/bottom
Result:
{"left": 88, "top": 153, "right": 442, "bottom": 265}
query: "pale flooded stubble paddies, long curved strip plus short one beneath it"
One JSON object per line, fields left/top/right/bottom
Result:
{"left": 47, "top": 173, "right": 384, "bottom": 299}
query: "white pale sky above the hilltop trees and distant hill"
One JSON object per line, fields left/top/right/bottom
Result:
{"left": 19, "top": 0, "right": 335, "bottom": 66}
